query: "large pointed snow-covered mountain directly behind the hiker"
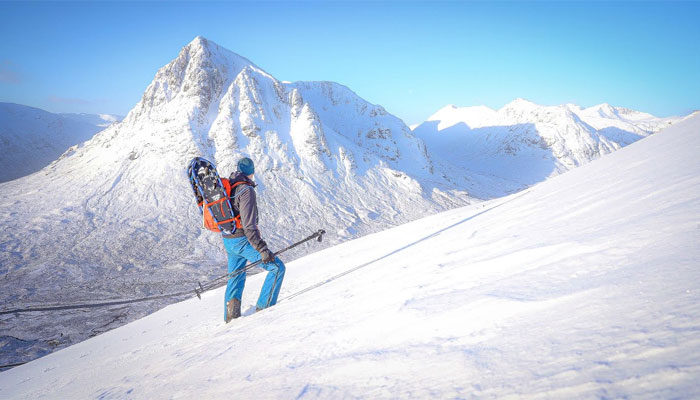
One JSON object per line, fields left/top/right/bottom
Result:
{"left": 0, "top": 37, "right": 470, "bottom": 362}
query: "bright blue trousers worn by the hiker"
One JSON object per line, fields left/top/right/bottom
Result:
{"left": 223, "top": 236, "right": 285, "bottom": 318}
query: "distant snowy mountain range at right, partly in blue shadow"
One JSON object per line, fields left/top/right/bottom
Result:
{"left": 413, "top": 99, "right": 682, "bottom": 191}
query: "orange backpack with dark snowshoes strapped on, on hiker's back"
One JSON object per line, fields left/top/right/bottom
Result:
{"left": 187, "top": 157, "right": 240, "bottom": 235}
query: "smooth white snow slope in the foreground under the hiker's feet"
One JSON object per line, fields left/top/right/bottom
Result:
{"left": 0, "top": 104, "right": 700, "bottom": 399}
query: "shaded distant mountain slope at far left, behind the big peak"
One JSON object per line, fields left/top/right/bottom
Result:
{"left": 0, "top": 103, "right": 119, "bottom": 182}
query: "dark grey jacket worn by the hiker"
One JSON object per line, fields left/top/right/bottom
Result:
{"left": 223, "top": 172, "right": 267, "bottom": 253}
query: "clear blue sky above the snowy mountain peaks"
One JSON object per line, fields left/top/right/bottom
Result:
{"left": 0, "top": 1, "right": 700, "bottom": 124}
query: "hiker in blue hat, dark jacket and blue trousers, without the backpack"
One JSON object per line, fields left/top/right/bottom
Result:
{"left": 222, "top": 157, "right": 285, "bottom": 323}
